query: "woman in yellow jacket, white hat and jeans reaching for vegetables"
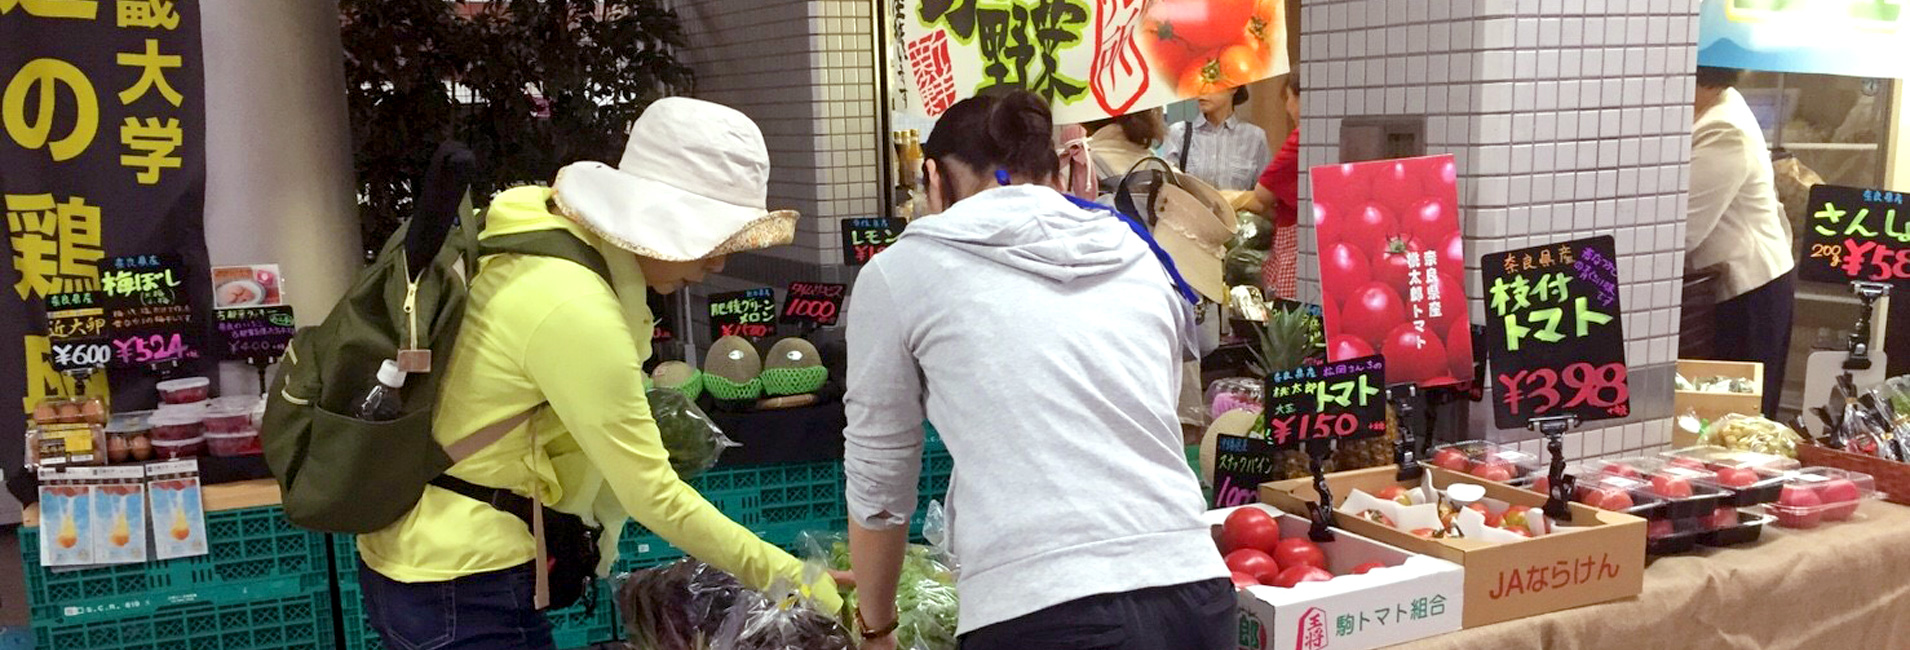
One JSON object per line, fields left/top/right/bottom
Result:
{"left": 359, "top": 98, "right": 840, "bottom": 650}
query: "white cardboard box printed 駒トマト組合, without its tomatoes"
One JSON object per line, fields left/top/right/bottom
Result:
{"left": 1205, "top": 505, "right": 1465, "bottom": 650}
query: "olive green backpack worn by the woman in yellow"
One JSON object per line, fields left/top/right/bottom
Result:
{"left": 260, "top": 203, "right": 609, "bottom": 533}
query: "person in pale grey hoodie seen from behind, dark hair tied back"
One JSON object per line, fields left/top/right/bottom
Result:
{"left": 842, "top": 90, "right": 1238, "bottom": 650}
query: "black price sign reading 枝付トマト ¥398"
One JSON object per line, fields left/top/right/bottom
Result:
{"left": 1482, "top": 235, "right": 1631, "bottom": 428}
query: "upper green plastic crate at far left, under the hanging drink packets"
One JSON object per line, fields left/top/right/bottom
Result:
{"left": 19, "top": 507, "right": 330, "bottom": 627}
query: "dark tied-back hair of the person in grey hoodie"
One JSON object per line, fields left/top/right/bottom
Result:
{"left": 923, "top": 86, "right": 1060, "bottom": 182}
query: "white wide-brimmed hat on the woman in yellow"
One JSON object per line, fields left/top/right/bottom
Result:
{"left": 552, "top": 98, "right": 796, "bottom": 262}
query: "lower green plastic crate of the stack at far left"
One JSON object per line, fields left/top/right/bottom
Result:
{"left": 32, "top": 585, "right": 338, "bottom": 650}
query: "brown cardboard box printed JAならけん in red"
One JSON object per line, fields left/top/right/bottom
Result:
{"left": 1261, "top": 466, "right": 1645, "bottom": 627}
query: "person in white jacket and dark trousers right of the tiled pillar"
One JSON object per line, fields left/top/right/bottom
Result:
{"left": 1685, "top": 67, "right": 1797, "bottom": 419}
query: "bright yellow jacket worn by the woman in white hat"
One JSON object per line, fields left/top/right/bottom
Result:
{"left": 357, "top": 187, "right": 840, "bottom": 612}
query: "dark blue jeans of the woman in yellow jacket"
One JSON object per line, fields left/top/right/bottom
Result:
{"left": 359, "top": 562, "right": 556, "bottom": 650}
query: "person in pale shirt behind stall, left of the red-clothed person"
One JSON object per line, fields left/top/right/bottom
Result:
{"left": 1161, "top": 86, "right": 1274, "bottom": 191}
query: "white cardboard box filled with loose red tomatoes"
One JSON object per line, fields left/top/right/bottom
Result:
{"left": 1207, "top": 505, "right": 1465, "bottom": 650}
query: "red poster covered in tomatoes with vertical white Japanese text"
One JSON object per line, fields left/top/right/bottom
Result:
{"left": 1308, "top": 155, "right": 1473, "bottom": 388}
